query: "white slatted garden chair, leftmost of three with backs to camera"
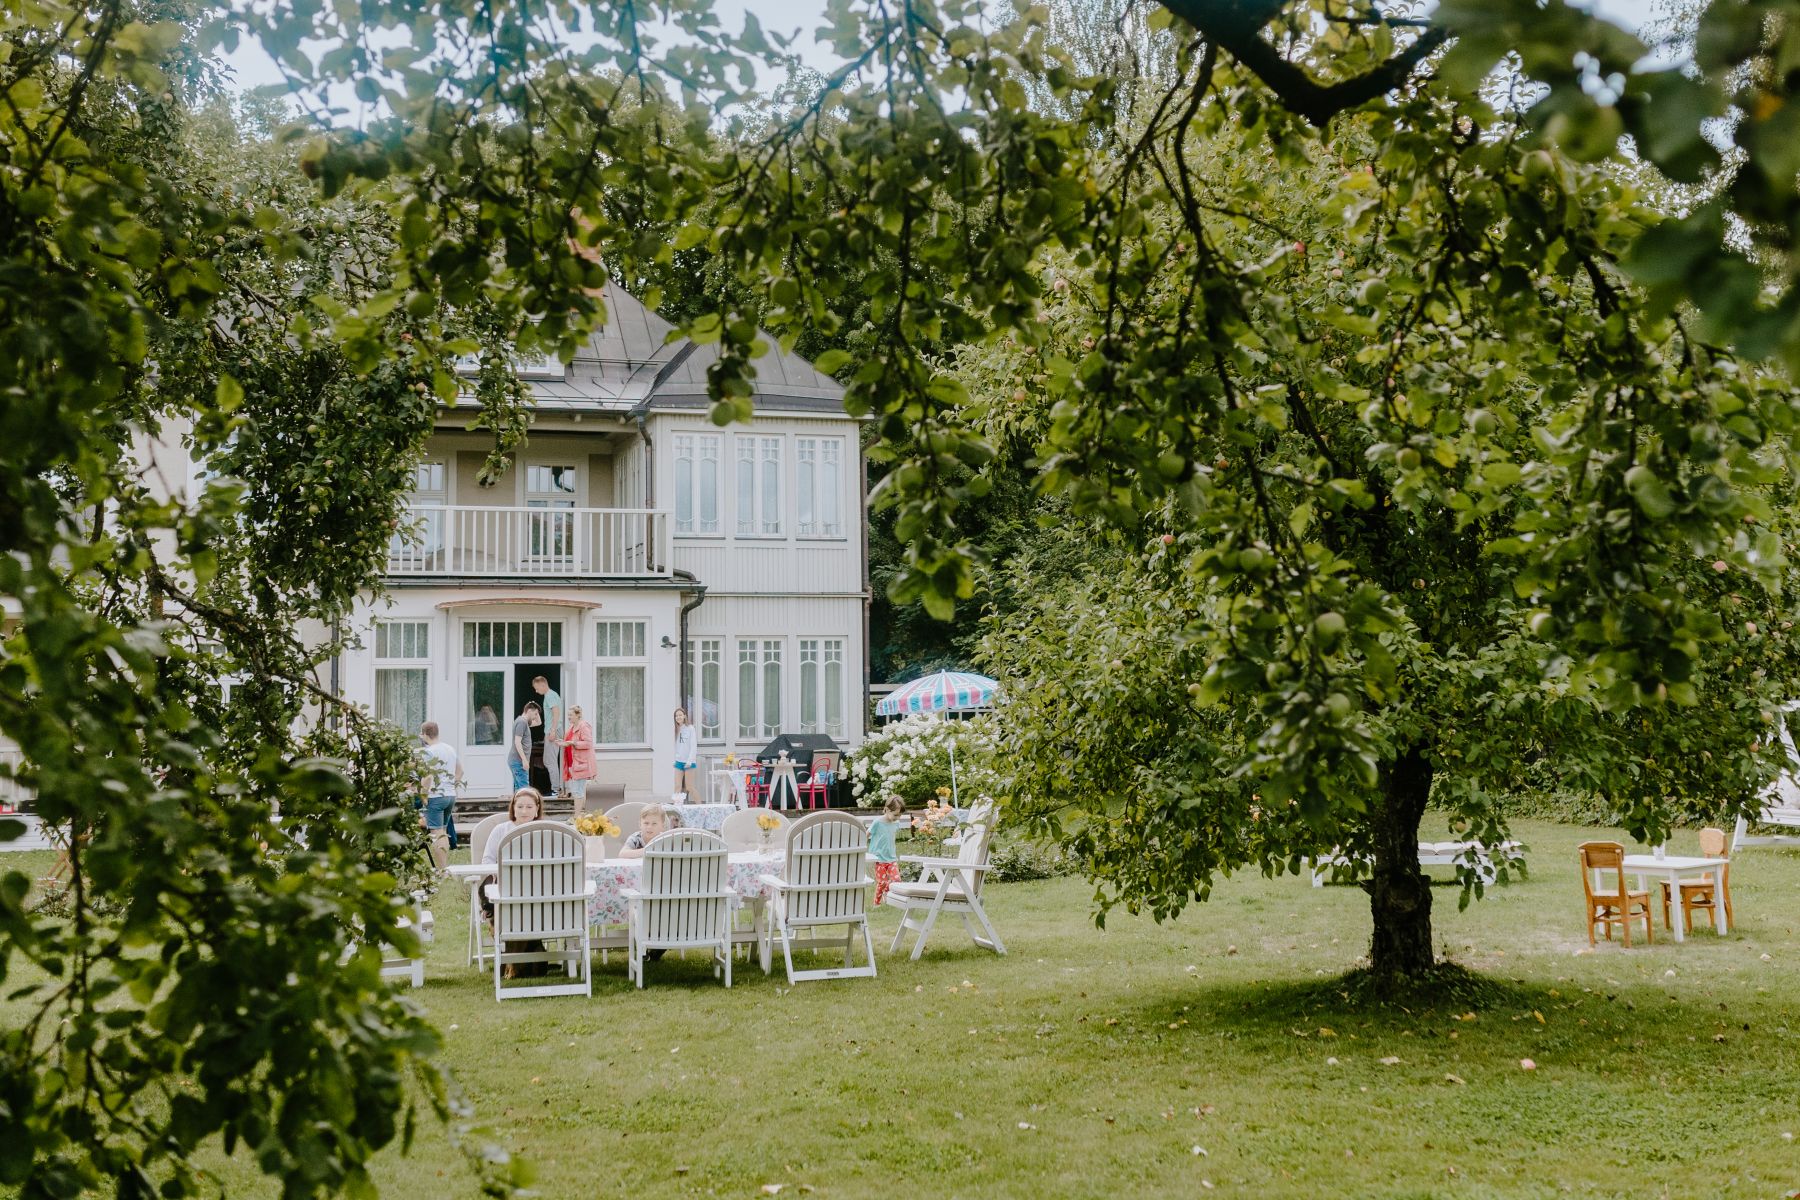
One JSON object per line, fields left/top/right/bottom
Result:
{"left": 484, "top": 820, "right": 594, "bottom": 1000}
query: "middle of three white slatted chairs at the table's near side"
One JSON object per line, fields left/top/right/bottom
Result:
{"left": 621, "top": 829, "right": 738, "bottom": 988}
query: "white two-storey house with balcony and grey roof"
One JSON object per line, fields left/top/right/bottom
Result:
{"left": 337, "top": 288, "right": 868, "bottom": 799}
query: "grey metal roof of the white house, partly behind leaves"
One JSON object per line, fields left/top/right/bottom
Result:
{"left": 511, "top": 284, "right": 844, "bottom": 414}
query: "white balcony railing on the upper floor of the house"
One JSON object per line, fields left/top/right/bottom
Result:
{"left": 387, "top": 504, "right": 670, "bottom": 579}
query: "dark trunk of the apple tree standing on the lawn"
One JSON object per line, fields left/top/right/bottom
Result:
{"left": 1364, "top": 747, "right": 1436, "bottom": 979}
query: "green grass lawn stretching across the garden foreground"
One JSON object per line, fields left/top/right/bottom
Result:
{"left": 10, "top": 822, "right": 1800, "bottom": 1200}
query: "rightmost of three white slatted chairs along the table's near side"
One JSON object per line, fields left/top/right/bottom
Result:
{"left": 761, "top": 813, "right": 875, "bottom": 984}
